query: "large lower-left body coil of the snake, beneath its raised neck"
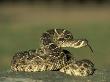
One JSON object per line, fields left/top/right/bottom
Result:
{"left": 11, "top": 50, "right": 74, "bottom": 72}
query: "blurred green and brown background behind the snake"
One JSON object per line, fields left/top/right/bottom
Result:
{"left": 0, "top": 0, "right": 110, "bottom": 70}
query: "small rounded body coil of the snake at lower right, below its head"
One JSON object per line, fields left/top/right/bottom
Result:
{"left": 59, "top": 59, "right": 95, "bottom": 76}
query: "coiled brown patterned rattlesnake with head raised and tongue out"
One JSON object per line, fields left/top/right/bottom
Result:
{"left": 11, "top": 29, "right": 94, "bottom": 76}
